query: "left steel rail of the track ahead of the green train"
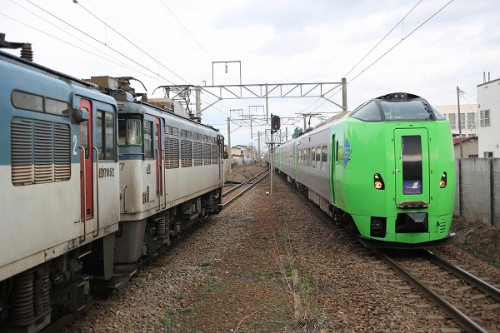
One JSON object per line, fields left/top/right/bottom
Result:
{"left": 372, "top": 249, "right": 488, "bottom": 333}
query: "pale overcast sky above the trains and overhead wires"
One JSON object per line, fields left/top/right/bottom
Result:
{"left": 0, "top": 0, "right": 500, "bottom": 145}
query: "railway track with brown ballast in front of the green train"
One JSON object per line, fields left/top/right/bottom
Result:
{"left": 374, "top": 250, "right": 500, "bottom": 333}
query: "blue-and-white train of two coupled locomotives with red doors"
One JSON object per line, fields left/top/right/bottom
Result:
{"left": 0, "top": 52, "right": 224, "bottom": 332}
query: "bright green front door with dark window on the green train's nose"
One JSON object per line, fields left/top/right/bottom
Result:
{"left": 394, "top": 128, "right": 430, "bottom": 205}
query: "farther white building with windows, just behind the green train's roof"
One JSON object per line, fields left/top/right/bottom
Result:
{"left": 434, "top": 104, "right": 479, "bottom": 137}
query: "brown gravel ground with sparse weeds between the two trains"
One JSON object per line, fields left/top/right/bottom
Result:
{"left": 65, "top": 169, "right": 498, "bottom": 333}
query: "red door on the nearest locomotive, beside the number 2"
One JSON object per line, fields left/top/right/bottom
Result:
{"left": 80, "top": 99, "right": 94, "bottom": 221}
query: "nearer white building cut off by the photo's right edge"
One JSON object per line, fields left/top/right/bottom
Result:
{"left": 477, "top": 79, "right": 500, "bottom": 157}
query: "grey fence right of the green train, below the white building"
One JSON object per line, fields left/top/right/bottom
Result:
{"left": 455, "top": 158, "right": 500, "bottom": 228}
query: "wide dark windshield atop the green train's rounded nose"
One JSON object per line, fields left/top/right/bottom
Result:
{"left": 351, "top": 99, "right": 446, "bottom": 121}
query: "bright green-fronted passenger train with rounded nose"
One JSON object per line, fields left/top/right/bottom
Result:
{"left": 274, "top": 93, "right": 456, "bottom": 248}
